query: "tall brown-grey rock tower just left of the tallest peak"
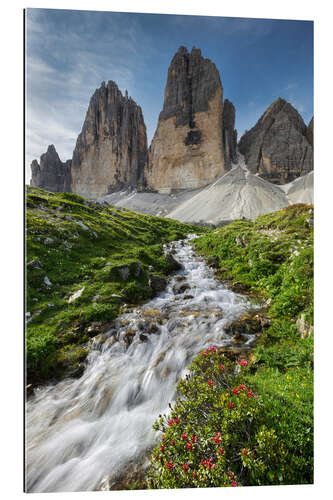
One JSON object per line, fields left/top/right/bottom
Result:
{"left": 71, "top": 81, "right": 147, "bottom": 198}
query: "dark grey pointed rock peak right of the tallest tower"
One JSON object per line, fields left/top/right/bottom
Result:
{"left": 238, "top": 97, "right": 313, "bottom": 184}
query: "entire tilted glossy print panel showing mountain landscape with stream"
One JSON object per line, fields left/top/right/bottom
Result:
{"left": 25, "top": 9, "right": 314, "bottom": 492}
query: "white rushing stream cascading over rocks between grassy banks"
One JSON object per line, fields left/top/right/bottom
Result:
{"left": 26, "top": 236, "right": 254, "bottom": 492}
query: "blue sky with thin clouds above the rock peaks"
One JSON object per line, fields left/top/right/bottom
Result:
{"left": 26, "top": 9, "right": 313, "bottom": 180}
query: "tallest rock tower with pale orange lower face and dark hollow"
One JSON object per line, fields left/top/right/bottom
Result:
{"left": 145, "top": 47, "right": 232, "bottom": 192}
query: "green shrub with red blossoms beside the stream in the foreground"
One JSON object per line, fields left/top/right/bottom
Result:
{"left": 148, "top": 347, "right": 288, "bottom": 488}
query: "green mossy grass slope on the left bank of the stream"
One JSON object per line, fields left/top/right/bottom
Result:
{"left": 26, "top": 188, "right": 203, "bottom": 382}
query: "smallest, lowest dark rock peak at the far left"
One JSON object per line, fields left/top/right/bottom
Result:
{"left": 30, "top": 144, "right": 71, "bottom": 192}
